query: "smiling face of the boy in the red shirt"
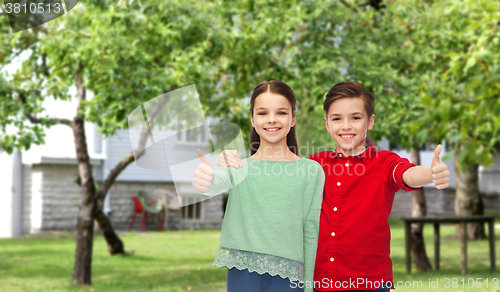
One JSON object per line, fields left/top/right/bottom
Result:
{"left": 325, "top": 98, "right": 375, "bottom": 156}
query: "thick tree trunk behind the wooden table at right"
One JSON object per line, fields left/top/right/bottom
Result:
{"left": 454, "top": 146, "right": 486, "bottom": 239}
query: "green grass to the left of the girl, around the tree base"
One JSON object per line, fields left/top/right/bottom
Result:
{"left": 0, "top": 230, "right": 226, "bottom": 292}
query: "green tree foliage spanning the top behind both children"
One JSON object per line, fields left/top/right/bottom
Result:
{"left": 0, "top": 0, "right": 500, "bottom": 166}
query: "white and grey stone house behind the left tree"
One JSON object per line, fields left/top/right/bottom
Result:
{"left": 0, "top": 120, "right": 227, "bottom": 237}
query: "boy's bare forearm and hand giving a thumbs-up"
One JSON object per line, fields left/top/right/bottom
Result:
{"left": 403, "top": 145, "right": 450, "bottom": 189}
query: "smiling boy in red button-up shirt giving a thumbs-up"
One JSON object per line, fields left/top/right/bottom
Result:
{"left": 215, "top": 81, "right": 449, "bottom": 291}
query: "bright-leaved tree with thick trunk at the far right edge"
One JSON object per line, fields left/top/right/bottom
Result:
{"left": 390, "top": 1, "right": 500, "bottom": 239}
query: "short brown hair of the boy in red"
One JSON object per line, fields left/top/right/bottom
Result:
{"left": 323, "top": 81, "right": 375, "bottom": 118}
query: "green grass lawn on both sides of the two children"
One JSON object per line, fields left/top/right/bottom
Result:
{"left": 0, "top": 220, "right": 500, "bottom": 292}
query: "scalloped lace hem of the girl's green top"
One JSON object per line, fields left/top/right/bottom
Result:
{"left": 213, "top": 247, "right": 304, "bottom": 282}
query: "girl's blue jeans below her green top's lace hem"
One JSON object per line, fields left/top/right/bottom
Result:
{"left": 226, "top": 268, "right": 303, "bottom": 292}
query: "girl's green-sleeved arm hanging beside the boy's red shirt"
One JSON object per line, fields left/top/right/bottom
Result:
{"left": 303, "top": 163, "right": 325, "bottom": 292}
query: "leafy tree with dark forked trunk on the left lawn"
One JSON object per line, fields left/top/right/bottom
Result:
{"left": 0, "top": 1, "right": 233, "bottom": 284}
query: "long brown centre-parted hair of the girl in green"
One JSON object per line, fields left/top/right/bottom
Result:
{"left": 250, "top": 79, "right": 298, "bottom": 155}
